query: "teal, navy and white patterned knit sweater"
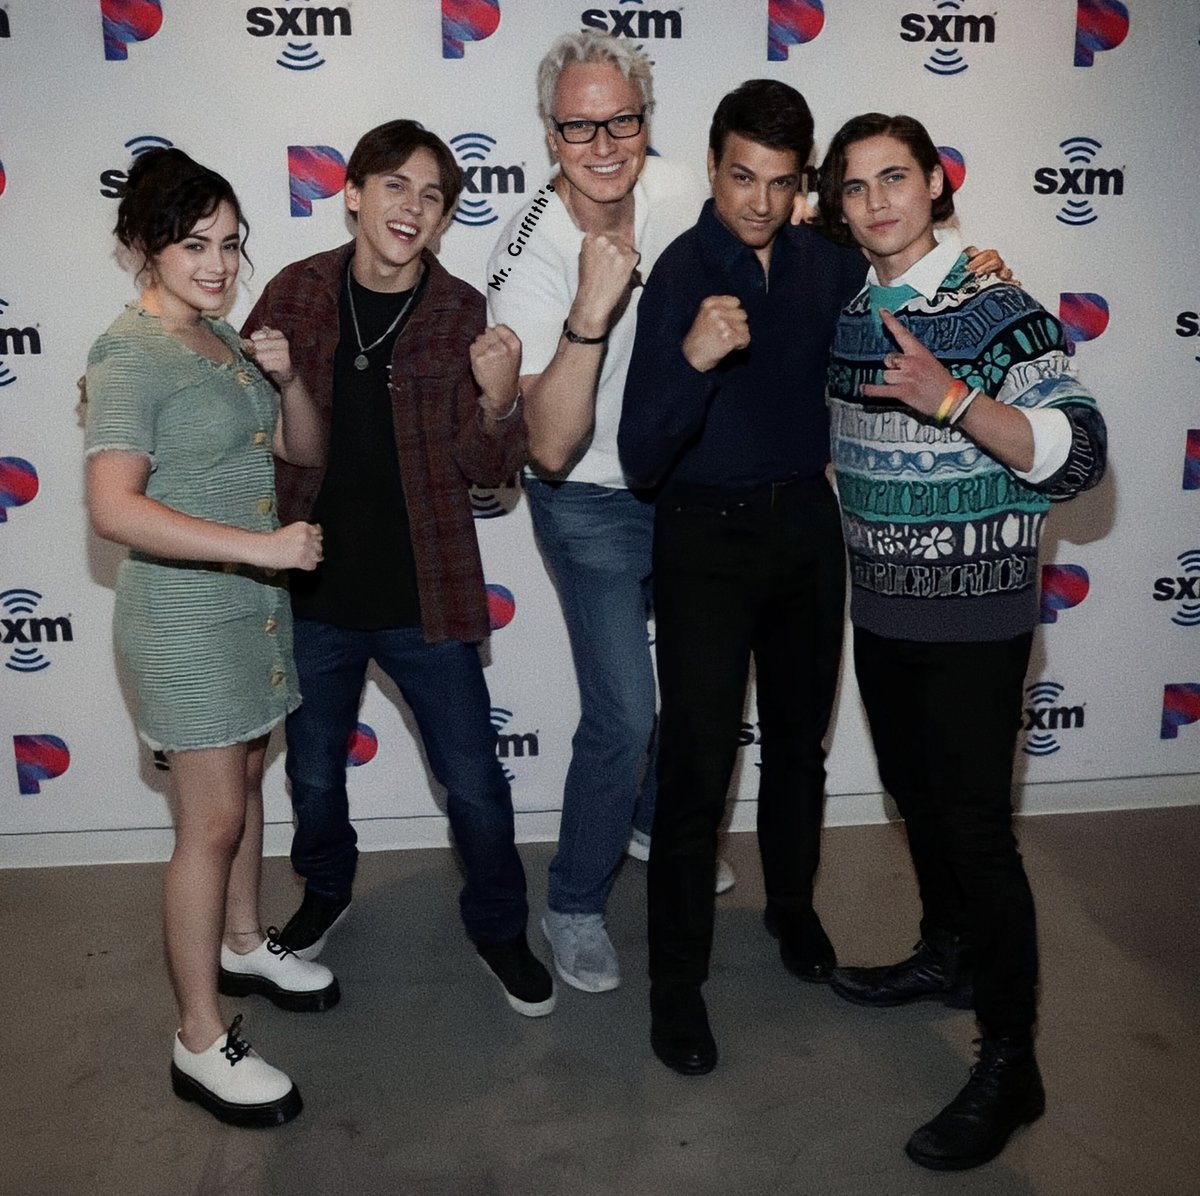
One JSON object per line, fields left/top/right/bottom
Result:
{"left": 829, "top": 256, "right": 1105, "bottom": 642}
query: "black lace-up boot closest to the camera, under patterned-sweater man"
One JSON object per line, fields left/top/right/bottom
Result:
{"left": 905, "top": 1038, "right": 1046, "bottom": 1171}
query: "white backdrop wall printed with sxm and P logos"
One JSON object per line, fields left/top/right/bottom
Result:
{"left": 0, "top": 0, "right": 1200, "bottom": 865}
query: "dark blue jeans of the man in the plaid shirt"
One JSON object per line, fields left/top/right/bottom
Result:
{"left": 286, "top": 619, "right": 528, "bottom": 945}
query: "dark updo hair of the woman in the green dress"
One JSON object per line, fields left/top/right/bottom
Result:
{"left": 113, "top": 149, "right": 250, "bottom": 262}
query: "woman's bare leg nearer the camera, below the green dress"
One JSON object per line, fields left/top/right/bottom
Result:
{"left": 163, "top": 744, "right": 250, "bottom": 1052}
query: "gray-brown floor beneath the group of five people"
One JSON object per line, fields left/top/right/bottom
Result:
{"left": 0, "top": 806, "right": 1200, "bottom": 1196}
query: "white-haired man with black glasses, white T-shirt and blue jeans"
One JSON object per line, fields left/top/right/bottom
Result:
{"left": 487, "top": 31, "right": 732, "bottom": 992}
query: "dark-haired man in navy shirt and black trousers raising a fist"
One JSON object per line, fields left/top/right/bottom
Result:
{"left": 618, "top": 79, "right": 866, "bottom": 1075}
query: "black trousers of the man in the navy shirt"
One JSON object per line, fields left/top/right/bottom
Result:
{"left": 647, "top": 477, "right": 845, "bottom": 985}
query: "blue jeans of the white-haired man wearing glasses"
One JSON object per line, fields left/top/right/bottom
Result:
{"left": 526, "top": 480, "right": 656, "bottom": 914}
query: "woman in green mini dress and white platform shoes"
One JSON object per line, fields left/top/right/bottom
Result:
{"left": 86, "top": 149, "right": 338, "bottom": 1125}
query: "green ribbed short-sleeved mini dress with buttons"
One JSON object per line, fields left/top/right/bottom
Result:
{"left": 85, "top": 305, "right": 300, "bottom": 751}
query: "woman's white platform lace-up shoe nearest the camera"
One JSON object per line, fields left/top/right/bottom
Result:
{"left": 170, "top": 1014, "right": 304, "bottom": 1126}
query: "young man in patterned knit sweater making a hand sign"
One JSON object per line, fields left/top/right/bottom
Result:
{"left": 821, "top": 114, "right": 1105, "bottom": 1170}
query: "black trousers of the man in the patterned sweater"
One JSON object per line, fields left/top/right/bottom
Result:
{"left": 854, "top": 627, "right": 1038, "bottom": 1036}
